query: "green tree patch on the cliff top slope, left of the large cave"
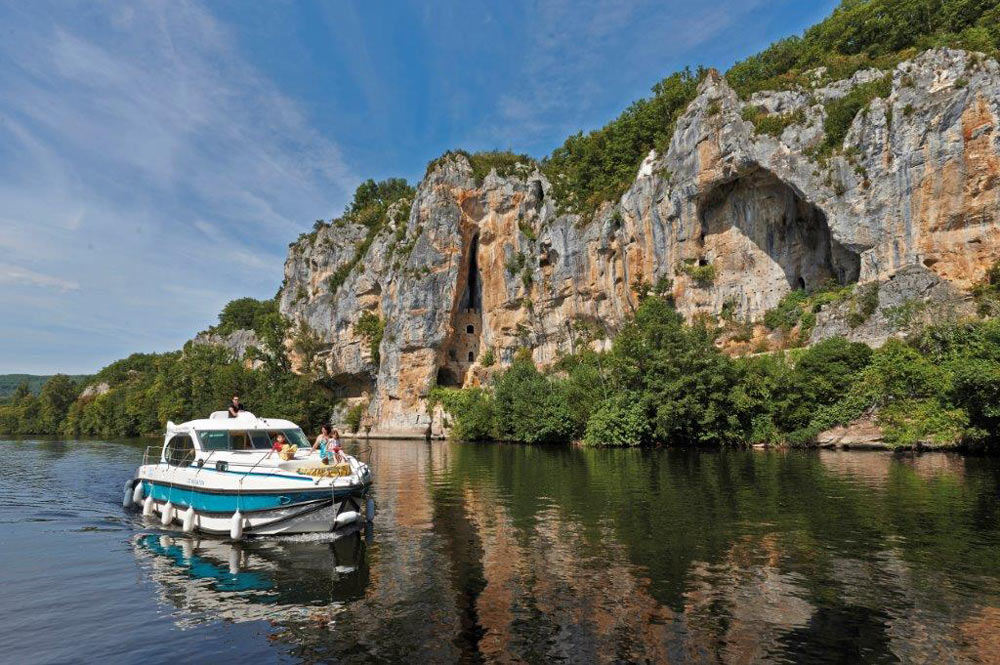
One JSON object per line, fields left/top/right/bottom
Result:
{"left": 542, "top": 69, "right": 705, "bottom": 219}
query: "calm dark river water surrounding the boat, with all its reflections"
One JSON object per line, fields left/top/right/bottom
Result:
{"left": 0, "top": 440, "right": 1000, "bottom": 665}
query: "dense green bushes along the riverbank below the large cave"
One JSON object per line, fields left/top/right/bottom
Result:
{"left": 441, "top": 291, "right": 1000, "bottom": 446}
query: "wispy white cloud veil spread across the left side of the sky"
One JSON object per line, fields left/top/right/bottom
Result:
{"left": 0, "top": 0, "right": 358, "bottom": 372}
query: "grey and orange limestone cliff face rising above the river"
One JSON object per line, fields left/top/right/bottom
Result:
{"left": 280, "top": 49, "right": 1000, "bottom": 436}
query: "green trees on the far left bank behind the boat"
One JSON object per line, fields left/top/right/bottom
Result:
{"left": 0, "top": 298, "right": 333, "bottom": 437}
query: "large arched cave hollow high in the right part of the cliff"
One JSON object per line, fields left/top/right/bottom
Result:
{"left": 699, "top": 167, "right": 861, "bottom": 314}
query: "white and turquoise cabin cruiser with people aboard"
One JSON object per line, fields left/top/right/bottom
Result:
{"left": 123, "top": 411, "right": 374, "bottom": 540}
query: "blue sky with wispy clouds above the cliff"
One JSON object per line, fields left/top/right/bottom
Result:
{"left": 0, "top": 0, "right": 836, "bottom": 373}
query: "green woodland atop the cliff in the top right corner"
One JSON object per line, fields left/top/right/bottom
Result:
{"left": 726, "top": 0, "right": 1000, "bottom": 96}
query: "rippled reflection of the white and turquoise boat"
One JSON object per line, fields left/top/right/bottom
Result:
{"left": 132, "top": 526, "right": 368, "bottom": 626}
